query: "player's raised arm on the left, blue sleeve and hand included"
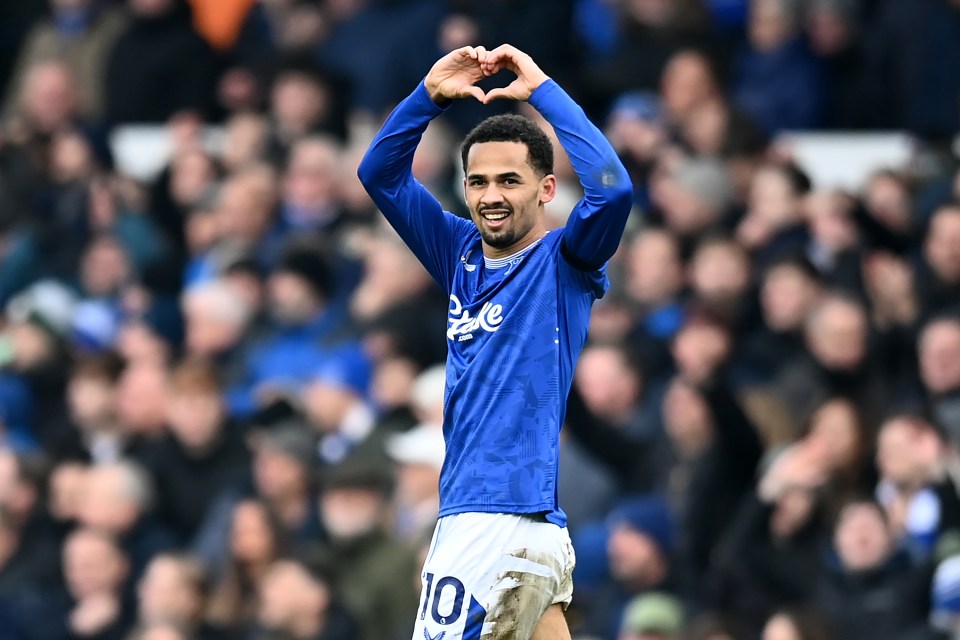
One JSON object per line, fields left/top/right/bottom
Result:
{"left": 357, "top": 47, "right": 486, "bottom": 291}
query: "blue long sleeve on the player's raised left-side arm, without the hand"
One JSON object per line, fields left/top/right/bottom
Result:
{"left": 357, "top": 82, "right": 473, "bottom": 292}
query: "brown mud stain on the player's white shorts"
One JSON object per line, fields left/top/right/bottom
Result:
{"left": 481, "top": 549, "right": 569, "bottom": 640}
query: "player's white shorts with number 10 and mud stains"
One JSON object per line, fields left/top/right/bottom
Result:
{"left": 413, "top": 513, "right": 576, "bottom": 640}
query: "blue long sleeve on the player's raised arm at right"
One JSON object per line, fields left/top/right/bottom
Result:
{"left": 530, "top": 80, "right": 633, "bottom": 270}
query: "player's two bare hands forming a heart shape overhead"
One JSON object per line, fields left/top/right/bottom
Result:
{"left": 424, "top": 44, "right": 549, "bottom": 104}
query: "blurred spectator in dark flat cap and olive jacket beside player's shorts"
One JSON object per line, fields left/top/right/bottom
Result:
{"left": 318, "top": 460, "right": 417, "bottom": 640}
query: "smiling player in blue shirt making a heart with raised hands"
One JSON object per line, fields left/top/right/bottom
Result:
{"left": 359, "top": 45, "right": 632, "bottom": 640}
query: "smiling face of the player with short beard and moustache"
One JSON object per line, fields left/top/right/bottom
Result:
{"left": 464, "top": 142, "right": 557, "bottom": 258}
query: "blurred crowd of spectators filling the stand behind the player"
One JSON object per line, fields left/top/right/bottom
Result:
{"left": 0, "top": 0, "right": 960, "bottom": 640}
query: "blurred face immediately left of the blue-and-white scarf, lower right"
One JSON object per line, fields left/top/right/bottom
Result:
{"left": 833, "top": 502, "right": 891, "bottom": 572}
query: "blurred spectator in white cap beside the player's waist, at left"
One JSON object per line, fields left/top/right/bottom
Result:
{"left": 386, "top": 424, "right": 446, "bottom": 543}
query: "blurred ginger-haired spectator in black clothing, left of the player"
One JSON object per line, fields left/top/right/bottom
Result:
{"left": 148, "top": 360, "right": 250, "bottom": 541}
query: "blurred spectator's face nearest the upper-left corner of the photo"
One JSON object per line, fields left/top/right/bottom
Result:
{"left": 21, "top": 61, "right": 78, "bottom": 133}
